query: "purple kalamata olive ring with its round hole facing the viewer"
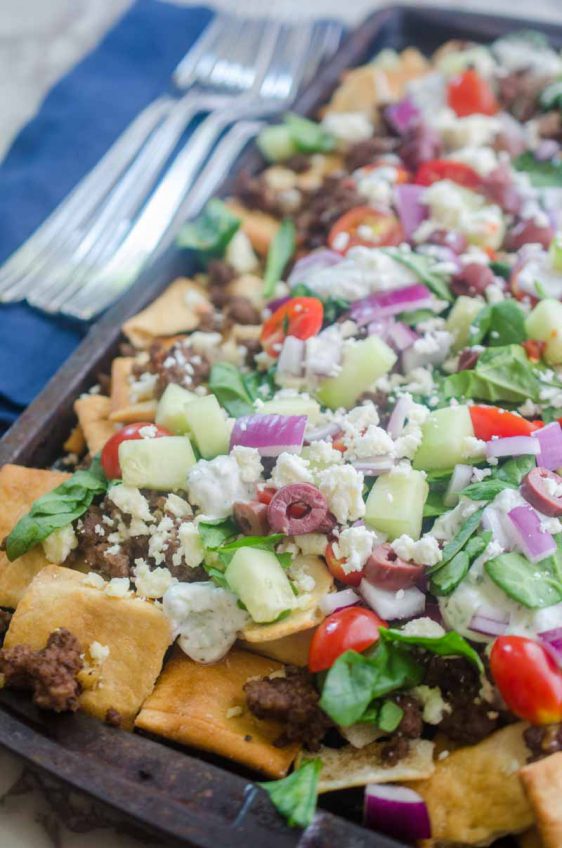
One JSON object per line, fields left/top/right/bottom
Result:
{"left": 267, "top": 483, "right": 328, "bottom": 535}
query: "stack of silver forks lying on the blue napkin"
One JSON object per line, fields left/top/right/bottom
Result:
{"left": 0, "top": 14, "right": 342, "bottom": 320}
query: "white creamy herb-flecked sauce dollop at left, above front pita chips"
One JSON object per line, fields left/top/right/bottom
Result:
{"left": 163, "top": 582, "right": 249, "bottom": 663}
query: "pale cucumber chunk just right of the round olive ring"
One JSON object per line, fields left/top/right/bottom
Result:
{"left": 365, "top": 469, "right": 429, "bottom": 540}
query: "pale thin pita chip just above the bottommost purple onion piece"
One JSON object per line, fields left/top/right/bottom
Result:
{"left": 301, "top": 739, "right": 435, "bottom": 793}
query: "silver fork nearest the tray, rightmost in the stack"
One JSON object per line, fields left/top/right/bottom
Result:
{"left": 60, "top": 23, "right": 342, "bottom": 318}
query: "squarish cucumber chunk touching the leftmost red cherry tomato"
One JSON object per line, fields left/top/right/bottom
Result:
{"left": 119, "top": 436, "right": 197, "bottom": 492}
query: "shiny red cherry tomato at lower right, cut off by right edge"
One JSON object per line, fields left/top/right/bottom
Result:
{"left": 490, "top": 636, "right": 562, "bottom": 724}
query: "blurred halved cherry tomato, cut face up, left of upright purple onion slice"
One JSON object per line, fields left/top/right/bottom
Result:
{"left": 328, "top": 206, "right": 404, "bottom": 253}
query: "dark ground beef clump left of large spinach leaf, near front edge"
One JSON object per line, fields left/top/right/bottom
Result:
{"left": 244, "top": 666, "right": 332, "bottom": 751}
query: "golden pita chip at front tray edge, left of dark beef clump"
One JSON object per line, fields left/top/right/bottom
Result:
{"left": 135, "top": 648, "right": 298, "bottom": 777}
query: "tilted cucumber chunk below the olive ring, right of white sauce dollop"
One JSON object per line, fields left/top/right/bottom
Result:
{"left": 225, "top": 548, "right": 295, "bottom": 624}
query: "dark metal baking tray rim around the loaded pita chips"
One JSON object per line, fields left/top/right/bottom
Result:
{"left": 0, "top": 6, "right": 562, "bottom": 848}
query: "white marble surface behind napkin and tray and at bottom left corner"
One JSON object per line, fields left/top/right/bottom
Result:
{"left": 0, "top": 0, "right": 562, "bottom": 848}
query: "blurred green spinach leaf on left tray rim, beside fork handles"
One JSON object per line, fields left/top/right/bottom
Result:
{"left": 177, "top": 197, "right": 240, "bottom": 265}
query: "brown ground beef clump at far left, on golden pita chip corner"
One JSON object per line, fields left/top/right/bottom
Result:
{"left": 0, "top": 627, "right": 82, "bottom": 712}
